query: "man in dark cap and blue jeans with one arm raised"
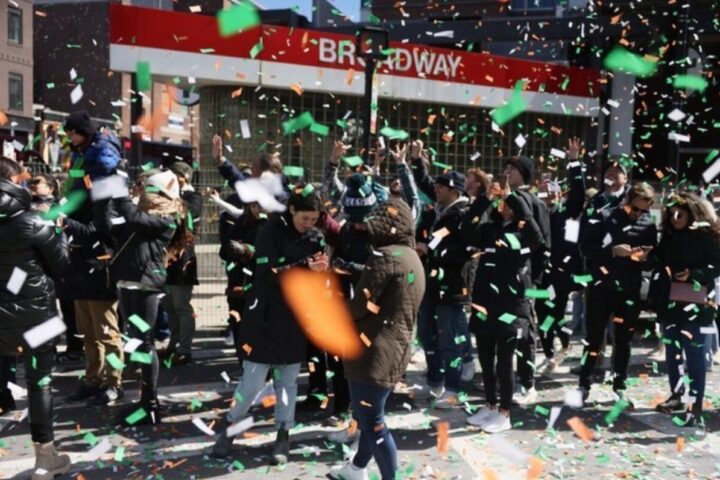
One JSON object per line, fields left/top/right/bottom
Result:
{"left": 410, "top": 140, "right": 470, "bottom": 409}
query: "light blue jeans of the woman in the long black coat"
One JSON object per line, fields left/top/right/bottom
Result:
{"left": 227, "top": 360, "right": 300, "bottom": 430}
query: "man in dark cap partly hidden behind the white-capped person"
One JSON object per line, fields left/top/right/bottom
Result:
{"left": 158, "top": 161, "right": 202, "bottom": 366}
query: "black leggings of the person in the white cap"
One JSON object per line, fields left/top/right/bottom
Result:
{"left": 118, "top": 288, "right": 160, "bottom": 405}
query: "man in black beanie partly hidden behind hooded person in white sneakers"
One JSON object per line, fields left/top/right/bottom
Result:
{"left": 503, "top": 155, "right": 551, "bottom": 405}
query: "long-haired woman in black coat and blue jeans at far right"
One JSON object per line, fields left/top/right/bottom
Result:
{"left": 650, "top": 192, "right": 720, "bottom": 426}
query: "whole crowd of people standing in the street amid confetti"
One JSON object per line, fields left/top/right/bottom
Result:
{"left": 0, "top": 112, "right": 720, "bottom": 480}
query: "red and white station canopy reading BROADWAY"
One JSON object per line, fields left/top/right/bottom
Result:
{"left": 110, "top": 4, "right": 601, "bottom": 117}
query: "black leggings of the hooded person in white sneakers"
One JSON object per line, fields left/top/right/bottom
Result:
{"left": 475, "top": 335, "right": 522, "bottom": 410}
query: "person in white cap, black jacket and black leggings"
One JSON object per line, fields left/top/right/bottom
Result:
{"left": 94, "top": 171, "right": 192, "bottom": 425}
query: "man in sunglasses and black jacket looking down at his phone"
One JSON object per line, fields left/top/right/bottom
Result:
{"left": 579, "top": 183, "right": 657, "bottom": 399}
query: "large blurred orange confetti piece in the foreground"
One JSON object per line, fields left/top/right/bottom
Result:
{"left": 280, "top": 268, "right": 363, "bottom": 359}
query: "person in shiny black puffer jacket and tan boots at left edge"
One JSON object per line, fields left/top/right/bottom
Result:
{"left": 0, "top": 158, "right": 70, "bottom": 480}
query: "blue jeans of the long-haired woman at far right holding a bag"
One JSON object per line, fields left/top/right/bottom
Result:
{"left": 661, "top": 318, "right": 705, "bottom": 415}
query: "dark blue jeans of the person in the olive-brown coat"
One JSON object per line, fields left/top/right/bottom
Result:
{"left": 348, "top": 380, "right": 397, "bottom": 480}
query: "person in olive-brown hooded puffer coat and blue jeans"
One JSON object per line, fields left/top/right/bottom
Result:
{"left": 330, "top": 198, "right": 425, "bottom": 480}
